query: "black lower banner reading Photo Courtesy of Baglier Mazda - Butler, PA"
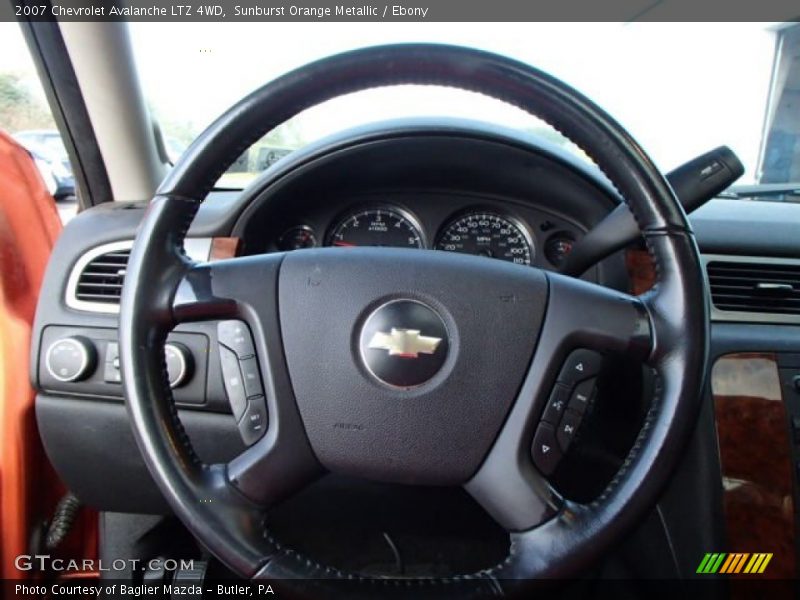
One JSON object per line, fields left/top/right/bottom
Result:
{"left": 2, "top": 577, "right": 800, "bottom": 600}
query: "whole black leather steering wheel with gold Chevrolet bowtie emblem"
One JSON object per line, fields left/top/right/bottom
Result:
{"left": 119, "top": 45, "right": 708, "bottom": 598}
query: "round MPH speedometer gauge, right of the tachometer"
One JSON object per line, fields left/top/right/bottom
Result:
{"left": 436, "top": 212, "right": 534, "bottom": 265}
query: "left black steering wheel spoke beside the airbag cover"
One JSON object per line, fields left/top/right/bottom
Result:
{"left": 172, "top": 255, "right": 321, "bottom": 508}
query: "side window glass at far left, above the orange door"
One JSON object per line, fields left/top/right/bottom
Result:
{"left": 0, "top": 23, "right": 78, "bottom": 223}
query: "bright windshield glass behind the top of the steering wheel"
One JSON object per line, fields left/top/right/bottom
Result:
{"left": 130, "top": 23, "right": 800, "bottom": 192}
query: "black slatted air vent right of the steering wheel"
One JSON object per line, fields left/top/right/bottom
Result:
{"left": 706, "top": 261, "right": 800, "bottom": 315}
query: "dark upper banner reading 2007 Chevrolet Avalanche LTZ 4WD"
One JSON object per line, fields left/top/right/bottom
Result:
{"left": 0, "top": 0, "right": 800, "bottom": 23}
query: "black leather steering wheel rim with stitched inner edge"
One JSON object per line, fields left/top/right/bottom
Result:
{"left": 120, "top": 45, "right": 708, "bottom": 597}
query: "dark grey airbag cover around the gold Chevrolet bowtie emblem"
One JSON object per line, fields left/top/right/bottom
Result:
{"left": 278, "top": 248, "right": 547, "bottom": 485}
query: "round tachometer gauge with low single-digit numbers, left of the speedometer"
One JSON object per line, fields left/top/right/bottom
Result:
{"left": 328, "top": 208, "right": 424, "bottom": 248}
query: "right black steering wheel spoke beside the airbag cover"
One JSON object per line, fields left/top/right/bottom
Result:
{"left": 466, "top": 274, "right": 652, "bottom": 531}
